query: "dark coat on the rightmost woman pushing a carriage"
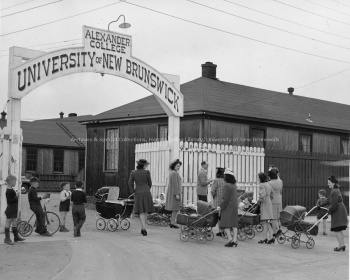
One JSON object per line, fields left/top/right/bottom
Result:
{"left": 321, "top": 188, "right": 348, "bottom": 230}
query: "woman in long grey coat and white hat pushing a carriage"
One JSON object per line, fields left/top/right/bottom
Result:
{"left": 218, "top": 169, "right": 238, "bottom": 247}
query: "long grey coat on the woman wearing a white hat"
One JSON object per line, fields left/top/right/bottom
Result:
{"left": 219, "top": 182, "right": 238, "bottom": 228}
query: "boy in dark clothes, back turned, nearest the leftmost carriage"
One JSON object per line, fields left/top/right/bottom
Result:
{"left": 71, "top": 181, "right": 87, "bottom": 237}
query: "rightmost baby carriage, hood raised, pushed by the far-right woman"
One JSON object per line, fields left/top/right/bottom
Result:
{"left": 277, "top": 205, "right": 328, "bottom": 249}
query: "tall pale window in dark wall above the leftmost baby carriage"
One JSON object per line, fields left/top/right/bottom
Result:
{"left": 105, "top": 129, "right": 119, "bottom": 170}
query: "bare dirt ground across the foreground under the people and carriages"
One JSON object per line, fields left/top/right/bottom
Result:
{"left": 0, "top": 193, "right": 349, "bottom": 280}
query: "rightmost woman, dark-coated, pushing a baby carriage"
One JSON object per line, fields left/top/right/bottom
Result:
{"left": 318, "top": 175, "right": 348, "bottom": 251}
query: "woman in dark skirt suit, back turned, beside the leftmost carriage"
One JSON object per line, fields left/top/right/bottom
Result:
{"left": 129, "top": 159, "right": 154, "bottom": 236}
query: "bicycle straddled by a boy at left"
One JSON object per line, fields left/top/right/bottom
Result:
{"left": 17, "top": 199, "right": 61, "bottom": 237}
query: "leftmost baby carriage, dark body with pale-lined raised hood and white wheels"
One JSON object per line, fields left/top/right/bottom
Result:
{"left": 94, "top": 187, "right": 134, "bottom": 231}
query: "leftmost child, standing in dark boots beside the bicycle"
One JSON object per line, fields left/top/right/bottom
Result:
{"left": 4, "top": 175, "right": 25, "bottom": 245}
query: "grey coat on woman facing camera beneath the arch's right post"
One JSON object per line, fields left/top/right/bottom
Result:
{"left": 165, "top": 170, "right": 182, "bottom": 211}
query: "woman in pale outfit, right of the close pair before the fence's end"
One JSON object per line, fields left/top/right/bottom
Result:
{"left": 268, "top": 168, "right": 283, "bottom": 238}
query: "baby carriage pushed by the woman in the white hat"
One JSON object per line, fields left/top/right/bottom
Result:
{"left": 176, "top": 200, "right": 219, "bottom": 244}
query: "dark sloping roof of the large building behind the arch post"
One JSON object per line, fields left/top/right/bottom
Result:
{"left": 81, "top": 77, "right": 350, "bottom": 131}
